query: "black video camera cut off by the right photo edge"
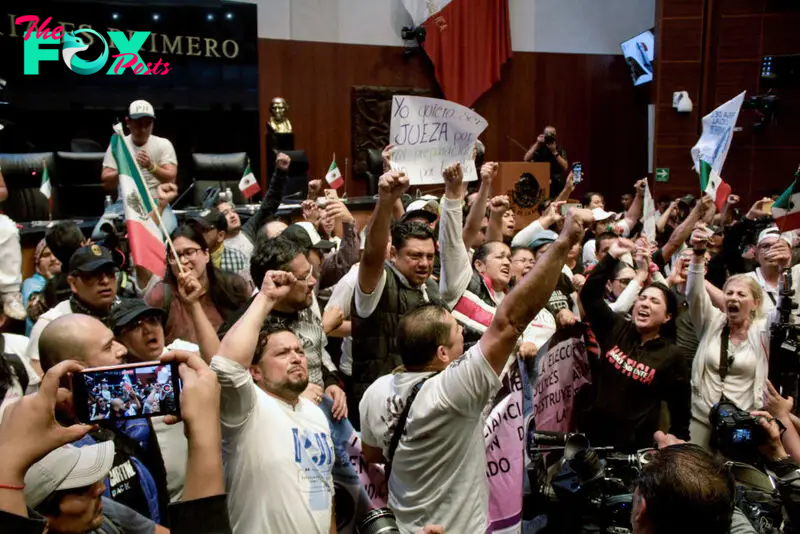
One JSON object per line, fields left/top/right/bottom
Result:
{"left": 769, "top": 269, "right": 800, "bottom": 409}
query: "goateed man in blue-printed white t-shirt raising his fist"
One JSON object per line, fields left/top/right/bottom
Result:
{"left": 211, "top": 271, "right": 336, "bottom": 534}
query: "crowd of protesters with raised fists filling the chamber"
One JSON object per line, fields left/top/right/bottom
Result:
{"left": 0, "top": 110, "right": 800, "bottom": 534}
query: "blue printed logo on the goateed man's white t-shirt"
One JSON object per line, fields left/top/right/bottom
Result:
{"left": 292, "top": 427, "right": 334, "bottom": 510}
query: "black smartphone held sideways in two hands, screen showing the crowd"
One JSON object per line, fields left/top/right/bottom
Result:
{"left": 72, "top": 362, "right": 181, "bottom": 424}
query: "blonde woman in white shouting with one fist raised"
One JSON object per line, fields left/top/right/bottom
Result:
{"left": 686, "top": 228, "right": 769, "bottom": 449}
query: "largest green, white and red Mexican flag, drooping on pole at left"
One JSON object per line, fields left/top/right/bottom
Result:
{"left": 111, "top": 124, "right": 167, "bottom": 277}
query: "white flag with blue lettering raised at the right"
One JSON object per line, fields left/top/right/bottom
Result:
{"left": 692, "top": 91, "right": 746, "bottom": 175}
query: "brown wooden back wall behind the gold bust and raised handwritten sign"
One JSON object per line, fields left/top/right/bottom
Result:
{"left": 259, "top": 39, "right": 650, "bottom": 206}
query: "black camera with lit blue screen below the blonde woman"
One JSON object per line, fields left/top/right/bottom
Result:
{"left": 709, "top": 398, "right": 769, "bottom": 463}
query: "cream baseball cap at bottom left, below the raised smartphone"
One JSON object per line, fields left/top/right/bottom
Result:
{"left": 24, "top": 441, "right": 114, "bottom": 508}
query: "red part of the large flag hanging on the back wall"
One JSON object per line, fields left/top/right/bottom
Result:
{"left": 423, "top": 0, "right": 511, "bottom": 106}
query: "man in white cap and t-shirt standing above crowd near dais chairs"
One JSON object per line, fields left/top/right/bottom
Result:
{"left": 97, "top": 100, "right": 178, "bottom": 238}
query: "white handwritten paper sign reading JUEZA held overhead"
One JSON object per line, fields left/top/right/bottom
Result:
{"left": 389, "top": 95, "right": 488, "bottom": 185}
